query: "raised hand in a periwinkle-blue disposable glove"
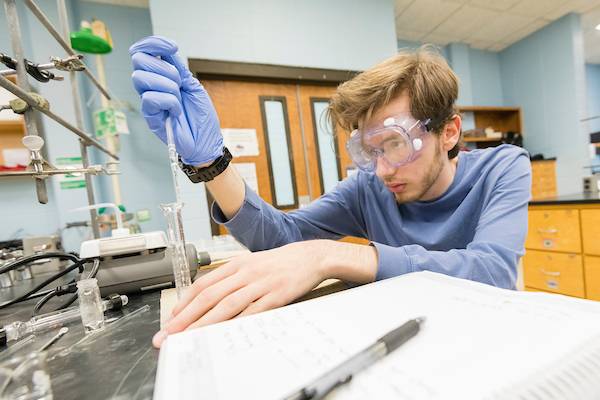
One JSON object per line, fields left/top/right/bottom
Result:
{"left": 129, "top": 36, "right": 223, "bottom": 166}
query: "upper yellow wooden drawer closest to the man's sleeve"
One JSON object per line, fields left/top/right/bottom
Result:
{"left": 525, "top": 209, "right": 581, "bottom": 253}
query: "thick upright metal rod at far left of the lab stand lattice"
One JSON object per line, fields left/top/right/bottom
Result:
{"left": 4, "top": 0, "right": 48, "bottom": 204}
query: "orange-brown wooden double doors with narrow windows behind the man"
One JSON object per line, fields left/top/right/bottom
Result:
{"left": 202, "top": 80, "right": 366, "bottom": 244}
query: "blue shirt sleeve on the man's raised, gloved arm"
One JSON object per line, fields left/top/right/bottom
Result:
{"left": 211, "top": 175, "right": 366, "bottom": 251}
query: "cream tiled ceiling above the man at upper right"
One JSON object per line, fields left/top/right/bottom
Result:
{"left": 394, "top": 0, "right": 600, "bottom": 64}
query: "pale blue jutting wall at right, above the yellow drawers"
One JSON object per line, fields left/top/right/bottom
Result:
{"left": 500, "top": 14, "right": 589, "bottom": 194}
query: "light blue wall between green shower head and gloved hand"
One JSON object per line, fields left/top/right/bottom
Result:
{"left": 73, "top": 1, "right": 174, "bottom": 231}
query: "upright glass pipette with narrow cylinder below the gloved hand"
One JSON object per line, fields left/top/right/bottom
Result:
{"left": 160, "top": 117, "right": 192, "bottom": 298}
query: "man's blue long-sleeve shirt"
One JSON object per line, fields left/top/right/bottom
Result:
{"left": 212, "top": 145, "right": 531, "bottom": 288}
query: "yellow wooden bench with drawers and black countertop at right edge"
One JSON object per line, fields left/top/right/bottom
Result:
{"left": 523, "top": 193, "right": 600, "bottom": 300}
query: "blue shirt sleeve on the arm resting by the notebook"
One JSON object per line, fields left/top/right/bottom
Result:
{"left": 373, "top": 152, "right": 531, "bottom": 289}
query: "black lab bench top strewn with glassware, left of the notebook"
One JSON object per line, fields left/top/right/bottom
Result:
{"left": 0, "top": 276, "right": 160, "bottom": 400}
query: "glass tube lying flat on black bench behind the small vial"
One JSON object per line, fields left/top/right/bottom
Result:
{"left": 3, "top": 295, "right": 129, "bottom": 342}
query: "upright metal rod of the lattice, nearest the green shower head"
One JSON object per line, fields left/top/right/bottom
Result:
{"left": 56, "top": 0, "right": 100, "bottom": 239}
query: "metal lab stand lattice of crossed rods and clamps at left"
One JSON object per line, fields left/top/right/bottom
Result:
{"left": 0, "top": 0, "right": 119, "bottom": 238}
